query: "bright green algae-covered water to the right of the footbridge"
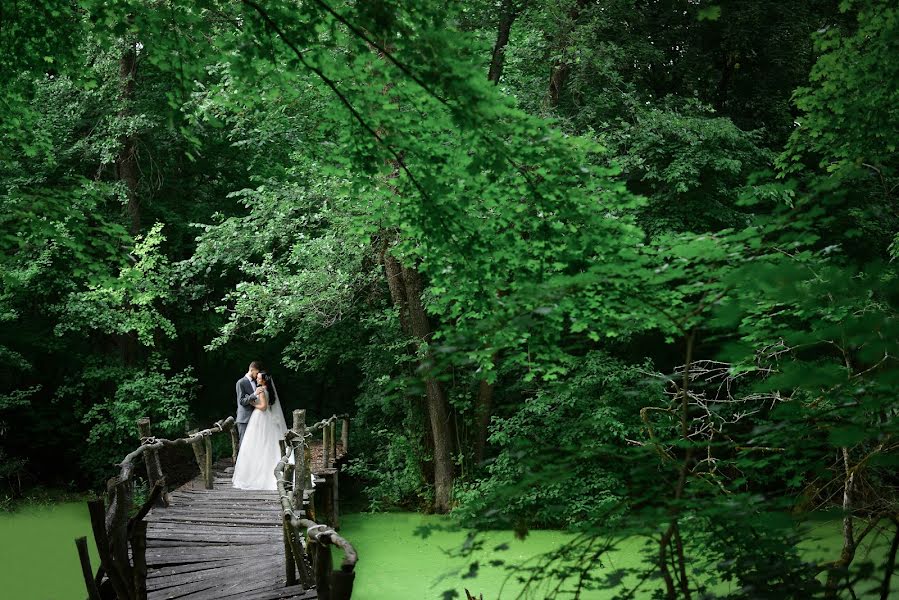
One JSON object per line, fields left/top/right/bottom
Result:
{"left": 334, "top": 513, "right": 899, "bottom": 600}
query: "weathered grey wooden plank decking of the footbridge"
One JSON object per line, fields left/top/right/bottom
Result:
{"left": 146, "top": 460, "right": 318, "bottom": 600}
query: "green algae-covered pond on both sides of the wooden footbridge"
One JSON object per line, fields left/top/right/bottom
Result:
{"left": 0, "top": 502, "right": 899, "bottom": 600}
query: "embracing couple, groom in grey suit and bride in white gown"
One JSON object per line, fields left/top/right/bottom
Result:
{"left": 231, "top": 361, "right": 287, "bottom": 490}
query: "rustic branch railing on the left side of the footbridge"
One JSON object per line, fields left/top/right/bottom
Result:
{"left": 75, "top": 417, "right": 238, "bottom": 600}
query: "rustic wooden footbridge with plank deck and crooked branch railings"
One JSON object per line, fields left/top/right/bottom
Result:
{"left": 75, "top": 410, "right": 357, "bottom": 600}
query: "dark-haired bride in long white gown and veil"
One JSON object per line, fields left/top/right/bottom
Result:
{"left": 231, "top": 371, "right": 287, "bottom": 490}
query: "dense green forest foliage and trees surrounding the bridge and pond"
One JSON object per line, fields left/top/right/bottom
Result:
{"left": 0, "top": 0, "right": 899, "bottom": 598}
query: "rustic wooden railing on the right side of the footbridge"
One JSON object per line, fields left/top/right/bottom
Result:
{"left": 275, "top": 410, "right": 358, "bottom": 600}
